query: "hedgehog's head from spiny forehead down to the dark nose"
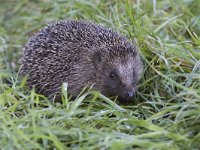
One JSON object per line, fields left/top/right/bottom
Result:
{"left": 91, "top": 45, "right": 143, "bottom": 98}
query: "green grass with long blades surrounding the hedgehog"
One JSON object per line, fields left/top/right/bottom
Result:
{"left": 0, "top": 0, "right": 200, "bottom": 150}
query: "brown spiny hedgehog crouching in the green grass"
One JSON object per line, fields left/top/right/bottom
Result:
{"left": 19, "top": 20, "right": 143, "bottom": 99}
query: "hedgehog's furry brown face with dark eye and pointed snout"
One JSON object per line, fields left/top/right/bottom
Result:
{"left": 93, "top": 48, "right": 143, "bottom": 100}
